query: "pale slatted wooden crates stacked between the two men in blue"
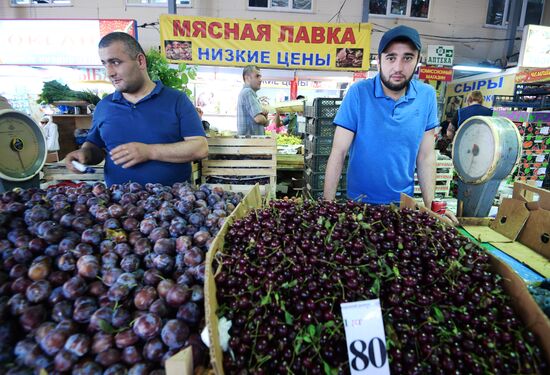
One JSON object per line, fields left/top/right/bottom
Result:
{"left": 201, "top": 136, "right": 277, "bottom": 196}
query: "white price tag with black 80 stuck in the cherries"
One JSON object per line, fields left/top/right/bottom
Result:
{"left": 340, "top": 299, "right": 390, "bottom": 375}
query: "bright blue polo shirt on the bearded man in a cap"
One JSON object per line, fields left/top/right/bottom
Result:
{"left": 334, "top": 75, "right": 439, "bottom": 204}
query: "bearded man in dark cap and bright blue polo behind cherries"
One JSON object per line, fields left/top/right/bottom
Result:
{"left": 324, "top": 26, "right": 439, "bottom": 207}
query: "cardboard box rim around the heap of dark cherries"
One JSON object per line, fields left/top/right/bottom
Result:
{"left": 205, "top": 187, "right": 550, "bottom": 375}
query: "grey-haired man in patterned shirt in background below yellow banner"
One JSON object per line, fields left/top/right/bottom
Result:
{"left": 237, "top": 65, "right": 269, "bottom": 135}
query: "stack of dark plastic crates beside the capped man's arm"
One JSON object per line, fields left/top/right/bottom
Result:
{"left": 304, "top": 98, "right": 347, "bottom": 199}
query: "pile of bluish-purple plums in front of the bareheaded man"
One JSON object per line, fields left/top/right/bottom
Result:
{"left": 0, "top": 183, "right": 241, "bottom": 374}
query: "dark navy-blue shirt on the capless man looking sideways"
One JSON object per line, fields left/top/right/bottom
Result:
{"left": 86, "top": 82, "right": 205, "bottom": 186}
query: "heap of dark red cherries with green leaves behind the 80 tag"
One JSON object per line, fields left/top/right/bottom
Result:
{"left": 218, "top": 200, "right": 548, "bottom": 374}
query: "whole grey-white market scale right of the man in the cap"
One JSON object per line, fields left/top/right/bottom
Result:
{"left": 453, "top": 116, "right": 522, "bottom": 217}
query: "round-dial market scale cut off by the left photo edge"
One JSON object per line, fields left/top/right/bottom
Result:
{"left": 0, "top": 109, "right": 47, "bottom": 192}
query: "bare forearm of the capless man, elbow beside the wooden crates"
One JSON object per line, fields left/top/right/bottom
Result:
{"left": 149, "top": 137, "right": 208, "bottom": 163}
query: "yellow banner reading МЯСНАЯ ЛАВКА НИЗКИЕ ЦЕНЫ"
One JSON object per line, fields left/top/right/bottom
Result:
{"left": 160, "top": 14, "right": 371, "bottom": 71}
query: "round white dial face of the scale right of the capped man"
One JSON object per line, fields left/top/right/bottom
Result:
{"left": 453, "top": 122, "right": 497, "bottom": 183}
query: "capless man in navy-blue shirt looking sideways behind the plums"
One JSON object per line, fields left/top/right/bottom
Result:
{"left": 66, "top": 32, "right": 208, "bottom": 186}
